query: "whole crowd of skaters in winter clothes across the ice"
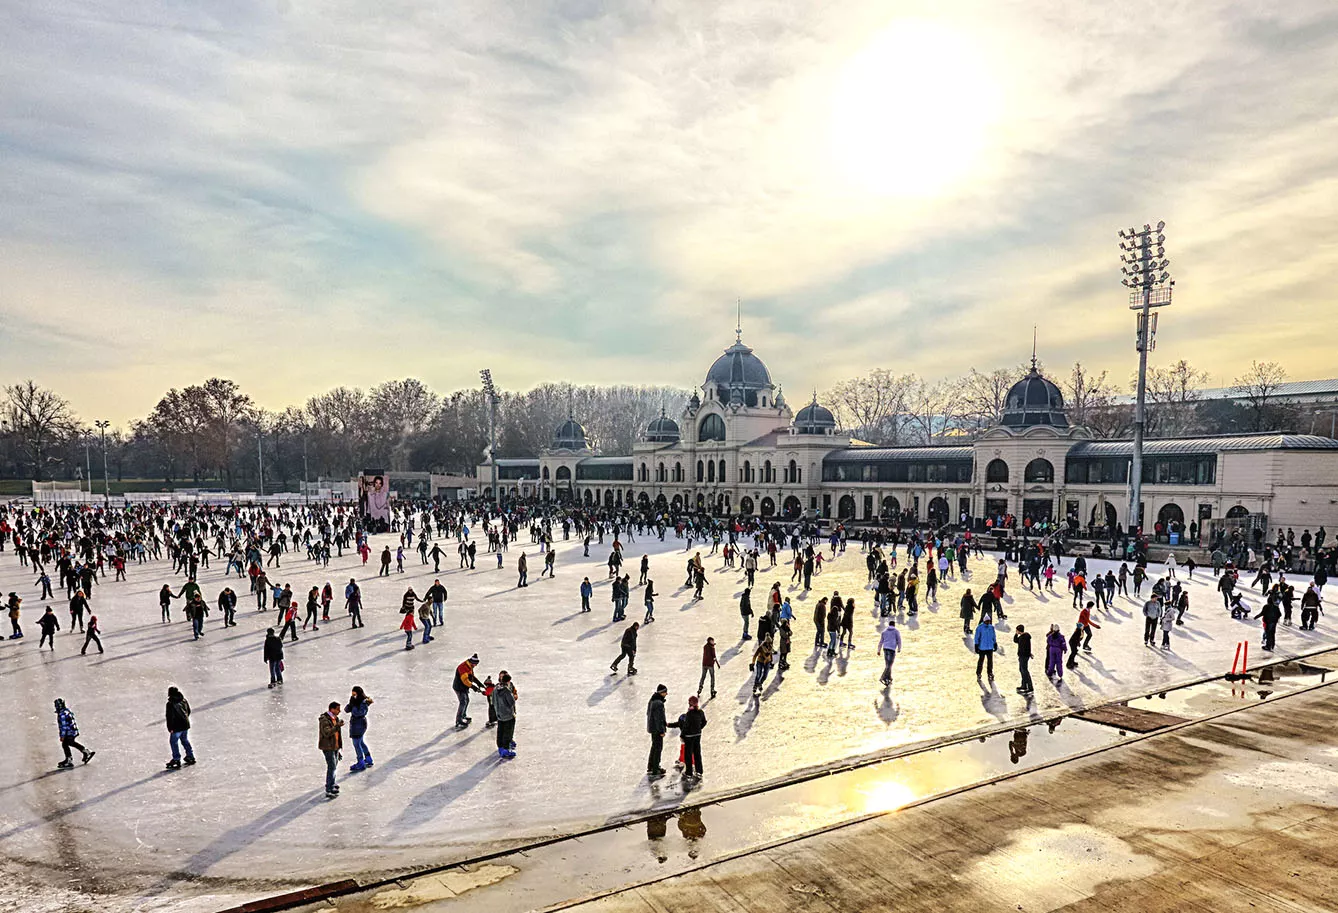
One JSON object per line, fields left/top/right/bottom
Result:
{"left": 0, "top": 502, "right": 1338, "bottom": 798}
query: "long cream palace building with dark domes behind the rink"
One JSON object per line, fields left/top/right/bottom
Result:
{"left": 478, "top": 332, "right": 1338, "bottom": 534}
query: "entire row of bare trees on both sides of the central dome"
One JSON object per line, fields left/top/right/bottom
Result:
{"left": 0, "top": 360, "right": 1316, "bottom": 490}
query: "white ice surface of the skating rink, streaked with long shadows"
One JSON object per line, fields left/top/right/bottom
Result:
{"left": 0, "top": 522, "right": 1338, "bottom": 909}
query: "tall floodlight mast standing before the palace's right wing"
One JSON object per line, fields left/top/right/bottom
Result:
{"left": 1120, "top": 222, "right": 1175, "bottom": 540}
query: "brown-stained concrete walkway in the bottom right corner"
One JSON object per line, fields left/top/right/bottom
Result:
{"left": 561, "top": 685, "right": 1338, "bottom": 913}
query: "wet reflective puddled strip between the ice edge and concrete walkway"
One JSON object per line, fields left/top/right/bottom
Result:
{"left": 318, "top": 653, "right": 1338, "bottom": 913}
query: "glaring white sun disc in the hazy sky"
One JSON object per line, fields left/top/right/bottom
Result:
{"left": 831, "top": 20, "right": 1001, "bottom": 197}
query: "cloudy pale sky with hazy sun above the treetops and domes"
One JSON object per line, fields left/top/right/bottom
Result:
{"left": 0, "top": 0, "right": 1338, "bottom": 423}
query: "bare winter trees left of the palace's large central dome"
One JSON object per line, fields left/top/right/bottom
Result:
{"left": 0, "top": 378, "right": 689, "bottom": 490}
